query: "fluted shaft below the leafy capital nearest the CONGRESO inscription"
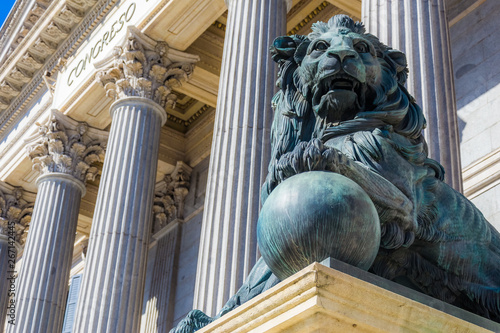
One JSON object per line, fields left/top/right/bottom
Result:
{"left": 74, "top": 97, "right": 166, "bottom": 333}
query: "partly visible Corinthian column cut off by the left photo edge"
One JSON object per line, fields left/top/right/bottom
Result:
{"left": 0, "top": 182, "right": 33, "bottom": 331}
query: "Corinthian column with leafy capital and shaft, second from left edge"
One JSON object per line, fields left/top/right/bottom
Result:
{"left": 8, "top": 111, "right": 107, "bottom": 333}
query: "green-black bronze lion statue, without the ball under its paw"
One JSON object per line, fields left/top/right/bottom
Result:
{"left": 172, "top": 15, "right": 500, "bottom": 332}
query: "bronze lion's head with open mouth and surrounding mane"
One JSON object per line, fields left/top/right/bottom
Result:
{"left": 263, "top": 15, "right": 432, "bottom": 200}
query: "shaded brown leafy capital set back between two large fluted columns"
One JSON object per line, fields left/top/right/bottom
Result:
{"left": 153, "top": 161, "right": 192, "bottom": 233}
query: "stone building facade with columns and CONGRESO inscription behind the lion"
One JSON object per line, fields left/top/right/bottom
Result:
{"left": 0, "top": 0, "right": 500, "bottom": 332}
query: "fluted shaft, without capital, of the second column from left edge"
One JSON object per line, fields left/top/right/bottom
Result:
{"left": 7, "top": 173, "right": 85, "bottom": 333}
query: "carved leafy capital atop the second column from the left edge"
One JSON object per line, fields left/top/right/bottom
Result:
{"left": 27, "top": 110, "right": 108, "bottom": 183}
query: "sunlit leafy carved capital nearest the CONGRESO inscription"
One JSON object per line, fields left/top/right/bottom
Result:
{"left": 96, "top": 27, "right": 199, "bottom": 108}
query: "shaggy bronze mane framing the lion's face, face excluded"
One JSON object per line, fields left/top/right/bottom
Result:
{"left": 262, "top": 15, "right": 444, "bottom": 201}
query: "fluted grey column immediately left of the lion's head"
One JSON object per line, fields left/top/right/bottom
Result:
{"left": 194, "top": 0, "right": 292, "bottom": 315}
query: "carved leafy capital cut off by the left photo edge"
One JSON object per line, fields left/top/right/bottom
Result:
{"left": 0, "top": 182, "right": 33, "bottom": 246}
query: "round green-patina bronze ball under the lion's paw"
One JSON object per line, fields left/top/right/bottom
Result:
{"left": 257, "top": 171, "right": 380, "bottom": 280}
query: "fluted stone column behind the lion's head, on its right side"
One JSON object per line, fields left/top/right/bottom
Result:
{"left": 362, "top": 0, "right": 462, "bottom": 191}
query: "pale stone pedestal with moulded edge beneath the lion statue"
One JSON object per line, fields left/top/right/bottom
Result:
{"left": 198, "top": 259, "right": 500, "bottom": 333}
